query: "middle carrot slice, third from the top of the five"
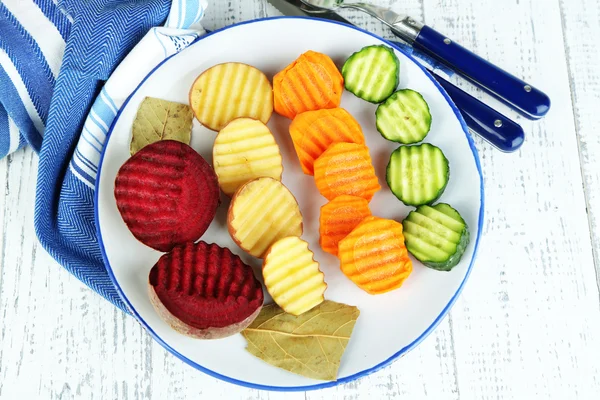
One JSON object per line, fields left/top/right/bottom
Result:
{"left": 315, "top": 143, "right": 381, "bottom": 201}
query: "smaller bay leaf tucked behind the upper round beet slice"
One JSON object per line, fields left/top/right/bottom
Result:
{"left": 129, "top": 97, "right": 193, "bottom": 155}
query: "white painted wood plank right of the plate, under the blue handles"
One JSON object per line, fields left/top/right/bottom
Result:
{"left": 425, "top": 0, "right": 600, "bottom": 399}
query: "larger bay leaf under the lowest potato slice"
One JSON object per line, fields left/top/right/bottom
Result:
{"left": 242, "top": 300, "right": 360, "bottom": 381}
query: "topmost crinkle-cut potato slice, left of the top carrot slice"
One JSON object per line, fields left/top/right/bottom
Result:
{"left": 189, "top": 62, "right": 273, "bottom": 131}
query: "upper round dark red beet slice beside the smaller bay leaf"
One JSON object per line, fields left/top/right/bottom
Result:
{"left": 115, "top": 140, "right": 220, "bottom": 252}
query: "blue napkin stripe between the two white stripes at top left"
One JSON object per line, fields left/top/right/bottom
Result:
{"left": 0, "top": 3, "right": 55, "bottom": 124}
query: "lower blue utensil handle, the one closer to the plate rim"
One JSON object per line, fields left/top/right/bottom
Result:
{"left": 432, "top": 74, "right": 525, "bottom": 152}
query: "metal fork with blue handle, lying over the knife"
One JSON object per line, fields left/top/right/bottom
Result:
{"left": 301, "top": 0, "right": 550, "bottom": 119}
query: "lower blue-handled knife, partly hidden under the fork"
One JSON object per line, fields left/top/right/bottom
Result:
{"left": 268, "top": 0, "right": 525, "bottom": 152}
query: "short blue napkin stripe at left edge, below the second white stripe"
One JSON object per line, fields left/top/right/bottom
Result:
{"left": 0, "top": 68, "right": 42, "bottom": 151}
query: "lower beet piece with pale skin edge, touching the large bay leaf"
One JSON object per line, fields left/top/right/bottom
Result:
{"left": 148, "top": 241, "right": 264, "bottom": 339}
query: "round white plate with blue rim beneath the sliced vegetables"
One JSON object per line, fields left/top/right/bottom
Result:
{"left": 96, "top": 18, "right": 483, "bottom": 390}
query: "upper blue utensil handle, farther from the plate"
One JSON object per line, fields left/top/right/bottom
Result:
{"left": 413, "top": 25, "right": 550, "bottom": 119}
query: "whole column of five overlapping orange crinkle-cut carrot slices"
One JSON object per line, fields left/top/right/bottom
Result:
{"left": 273, "top": 51, "right": 412, "bottom": 294}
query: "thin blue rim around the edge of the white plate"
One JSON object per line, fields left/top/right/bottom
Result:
{"left": 94, "top": 16, "right": 485, "bottom": 392}
